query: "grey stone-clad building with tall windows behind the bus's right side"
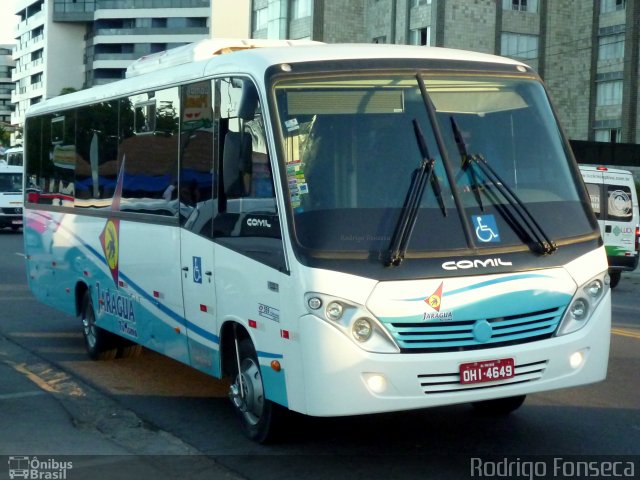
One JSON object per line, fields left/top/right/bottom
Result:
{"left": 251, "top": 0, "right": 640, "bottom": 143}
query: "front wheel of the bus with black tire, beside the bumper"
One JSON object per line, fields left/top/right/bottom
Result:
{"left": 229, "top": 338, "right": 285, "bottom": 443}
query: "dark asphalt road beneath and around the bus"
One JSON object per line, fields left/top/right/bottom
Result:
{"left": 0, "top": 231, "right": 640, "bottom": 480}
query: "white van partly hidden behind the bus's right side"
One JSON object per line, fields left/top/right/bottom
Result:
{"left": 580, "top": 165, "right": 640, "bottom": 287}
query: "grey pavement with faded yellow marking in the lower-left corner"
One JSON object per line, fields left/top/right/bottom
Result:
{"left": 0, "top": 335, "right": 240, "bottom": 480}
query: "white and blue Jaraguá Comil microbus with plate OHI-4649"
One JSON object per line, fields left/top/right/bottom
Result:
{"left": 25, "top": 40, "right": 611, "bottom": 441}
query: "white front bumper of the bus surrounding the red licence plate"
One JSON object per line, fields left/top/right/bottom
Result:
{"left": 296, "top": 293, "right": 611, "bottom": 416}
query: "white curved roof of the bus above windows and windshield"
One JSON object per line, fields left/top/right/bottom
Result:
{"left": 27, "top": 41, "right": 528, "bottom": 117}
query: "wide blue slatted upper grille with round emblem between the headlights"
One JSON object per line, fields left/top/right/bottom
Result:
{"left": 386, "top": 306, "right": 565, "bottom": 353}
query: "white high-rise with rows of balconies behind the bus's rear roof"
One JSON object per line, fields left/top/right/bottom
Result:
{"left": 11, "top": 0, "right": 211, "bottom": 130}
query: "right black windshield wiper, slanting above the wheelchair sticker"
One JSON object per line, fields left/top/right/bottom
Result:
{"left": 450, "top": 117, "right": 558, "bottom": 255}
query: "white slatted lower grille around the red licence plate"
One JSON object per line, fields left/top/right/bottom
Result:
{"left": 418, "top": 360, "right": 548, "bottom": 395}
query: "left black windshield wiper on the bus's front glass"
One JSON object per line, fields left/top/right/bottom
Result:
{"left": 385, "top": 118, "right": 447, "bottom": 267}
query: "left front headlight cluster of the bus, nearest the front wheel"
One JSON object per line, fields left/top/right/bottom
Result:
{"left": 304, "top": 292, "right": 400, "bottom": 353}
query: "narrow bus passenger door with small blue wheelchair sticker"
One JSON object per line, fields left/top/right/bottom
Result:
{"left": 176, "top": 80, "right": 220, "bottom": 376}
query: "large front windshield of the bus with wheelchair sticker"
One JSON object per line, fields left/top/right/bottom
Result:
{"left": 274, "top": 72, "right": 593, "bottom": 257}
